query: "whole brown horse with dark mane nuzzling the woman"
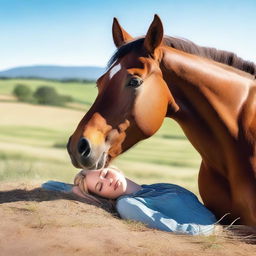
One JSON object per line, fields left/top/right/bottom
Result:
{"left": 68, "top": 16, "right": 256, "bottom": 226}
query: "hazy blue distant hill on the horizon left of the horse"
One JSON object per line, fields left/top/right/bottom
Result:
{"left": 0, "top": 66, "right": 105, "bottom": 80}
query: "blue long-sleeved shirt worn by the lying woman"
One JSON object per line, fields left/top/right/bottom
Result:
{"left": 116, "top": 183, "right": 216, "bottom": 235}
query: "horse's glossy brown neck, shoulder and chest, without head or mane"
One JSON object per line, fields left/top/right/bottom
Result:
{"left": 162, "top": 45, "right": 256, "bottom": 225}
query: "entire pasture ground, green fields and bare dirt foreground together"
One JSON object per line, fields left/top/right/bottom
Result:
{"left": 0, "top": 79, "right": 255, "bottom": 256}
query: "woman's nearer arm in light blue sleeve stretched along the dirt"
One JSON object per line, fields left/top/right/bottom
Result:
{"left": 116, "top": 197, "right": 215, "bottom": 235}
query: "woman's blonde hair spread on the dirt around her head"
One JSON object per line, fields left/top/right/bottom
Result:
{"left": 74, "top": 166, "right": 121, "bottom": 212}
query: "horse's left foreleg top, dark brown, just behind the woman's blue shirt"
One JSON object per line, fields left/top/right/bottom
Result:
{"left": 198, "top": 162, "right": 235, "bottom": 224}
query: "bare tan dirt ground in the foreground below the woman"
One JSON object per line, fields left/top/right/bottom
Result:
{"left": 0, "top": 183, "right": 256, "bottom": 256}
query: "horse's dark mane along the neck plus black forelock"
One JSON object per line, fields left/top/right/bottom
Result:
{"left": 108, "top": 36, "right": 256, "bottom": 76}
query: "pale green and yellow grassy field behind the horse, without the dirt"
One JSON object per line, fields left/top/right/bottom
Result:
{"left": 0, "top": 79, "right": 200, "bottom": 194}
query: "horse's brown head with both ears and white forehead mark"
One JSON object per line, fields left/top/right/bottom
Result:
{"left": 67, "top": 16, "right": 174, "bottom": 169}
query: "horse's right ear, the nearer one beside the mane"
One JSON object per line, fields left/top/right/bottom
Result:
{"left": 144, "top": 14, "right": 164, "bottom": 54}
